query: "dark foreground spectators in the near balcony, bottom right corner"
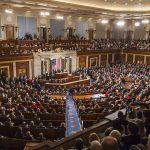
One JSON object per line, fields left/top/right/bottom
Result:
{"left": 69, "top": 109, "right": 150, "bottom": 150}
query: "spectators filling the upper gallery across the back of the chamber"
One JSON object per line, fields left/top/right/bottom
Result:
{"left": 0, "top": 38, "right": 150, "bottom": 55}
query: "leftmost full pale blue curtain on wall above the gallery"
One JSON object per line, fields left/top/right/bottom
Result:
{"left": 18, "top": 16, "right": 37, "bottom": 38}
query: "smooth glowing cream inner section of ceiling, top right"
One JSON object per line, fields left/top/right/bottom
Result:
{"left": 52, "top": 0, "right": 150, "bottom": 12}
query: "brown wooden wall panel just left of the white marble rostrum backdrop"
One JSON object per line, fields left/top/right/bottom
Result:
{"left": 16, "top": 61, "right": 29, "bottom": 77}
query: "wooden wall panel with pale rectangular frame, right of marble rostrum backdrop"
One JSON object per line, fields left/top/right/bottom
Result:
{"left": 88, "top": 55, "right": 99, "bottom": 67}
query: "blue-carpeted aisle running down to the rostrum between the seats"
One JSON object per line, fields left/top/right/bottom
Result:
{"left": 66, "top": 95, "right": 82, "bottom": 136}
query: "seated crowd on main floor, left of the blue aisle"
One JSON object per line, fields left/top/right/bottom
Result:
{"left": 0, "top": 74, "right": 65, "bottom": 140}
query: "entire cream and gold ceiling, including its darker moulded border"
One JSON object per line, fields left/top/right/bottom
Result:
{"left": 0, "top": 0, "right": 150, "bottom": 19}
